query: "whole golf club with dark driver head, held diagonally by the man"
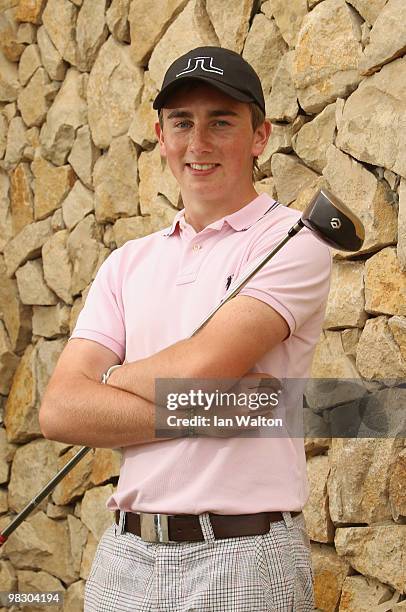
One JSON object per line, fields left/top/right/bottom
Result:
{"left": 0, "top": 189, "right": 364, "bottom": 546}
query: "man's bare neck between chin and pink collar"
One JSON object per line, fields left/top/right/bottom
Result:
{"left": 182, "top": 186, "right": 258, "bottom": 232}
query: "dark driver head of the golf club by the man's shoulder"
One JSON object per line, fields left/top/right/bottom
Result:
{"left": 301, "top": 189, "right": 365, "bottom": 251}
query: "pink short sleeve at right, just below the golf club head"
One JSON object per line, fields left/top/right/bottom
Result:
{"left": 237, "top": 229, "right": 332, "bottom": 335}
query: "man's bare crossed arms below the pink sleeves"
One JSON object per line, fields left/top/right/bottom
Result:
{"left": 39, "top": 296, "right": 289, "bottom": 448}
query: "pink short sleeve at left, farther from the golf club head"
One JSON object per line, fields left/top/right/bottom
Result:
{"left": 69, "top": 249, "right": 125, "bottom": 361}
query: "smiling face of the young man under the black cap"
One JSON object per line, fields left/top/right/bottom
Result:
{"left": 155, "top": 84, "right": 270, "bottom": 206}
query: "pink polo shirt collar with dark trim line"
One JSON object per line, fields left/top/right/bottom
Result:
{"left": 163, "top": 193, "right": 278, "bottom": 236}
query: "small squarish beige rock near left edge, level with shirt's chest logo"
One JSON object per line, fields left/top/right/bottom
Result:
{"left": 16, "top": 259, "right": 58, "bottom": 305}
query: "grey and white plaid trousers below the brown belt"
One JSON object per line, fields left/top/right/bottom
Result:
{"left": 84, "top": 512, "right": 314, "bottom": 612}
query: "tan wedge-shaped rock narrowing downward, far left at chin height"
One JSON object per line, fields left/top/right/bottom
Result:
{"left": 31, "top": 157, "right": 76, "bottom": 219}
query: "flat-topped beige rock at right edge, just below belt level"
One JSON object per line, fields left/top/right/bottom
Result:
{"left": 335, "top": 524, "right": 406, "bottom": 593}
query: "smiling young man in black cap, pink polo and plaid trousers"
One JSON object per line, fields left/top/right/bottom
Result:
{"left": 40, "top": 47, "right": 331, "bottom": 612}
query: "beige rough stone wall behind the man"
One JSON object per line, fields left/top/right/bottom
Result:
{"left": 0, "top": 0, "right": 406, "bottom": 612}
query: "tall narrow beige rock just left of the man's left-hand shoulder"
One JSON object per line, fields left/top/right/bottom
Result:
{"left": 66, "top": 215, "right": 109, "bottom": 295}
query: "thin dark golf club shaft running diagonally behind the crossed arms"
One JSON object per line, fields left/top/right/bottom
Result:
{"left": 0, "top": 219, "right": 304, "bottom": 547}
